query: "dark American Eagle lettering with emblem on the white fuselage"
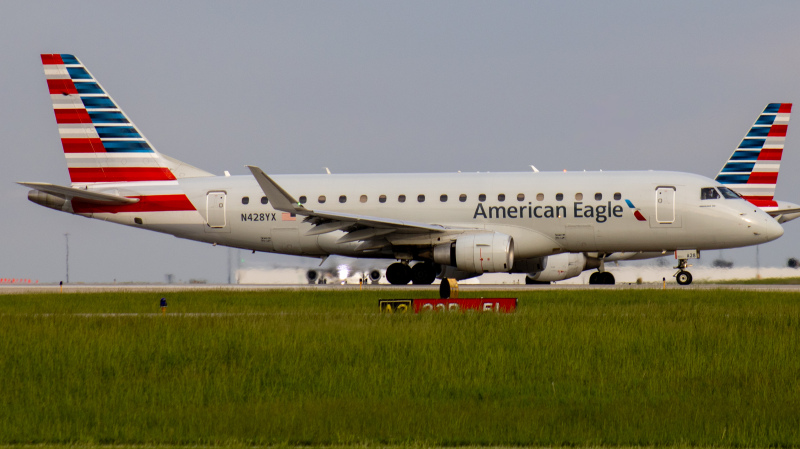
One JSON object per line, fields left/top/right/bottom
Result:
{"left": 472, "top": 200, "right": 647, "bottom": 223}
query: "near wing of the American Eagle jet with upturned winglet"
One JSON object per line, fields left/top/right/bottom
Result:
{"left": 247, "top": 165, "right": 456, "bottom": 249}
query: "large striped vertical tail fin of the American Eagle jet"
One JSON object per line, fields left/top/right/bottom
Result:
{"left": 42, "top": 54, "right": 213, "bottom": 186}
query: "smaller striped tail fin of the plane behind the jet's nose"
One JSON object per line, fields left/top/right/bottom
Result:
{"left": 715, "top": 103, "right": 792, "bottom": 207}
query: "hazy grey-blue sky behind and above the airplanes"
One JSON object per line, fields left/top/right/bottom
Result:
{"left": 0, "top": 1, "right": 800, "bottom": 282}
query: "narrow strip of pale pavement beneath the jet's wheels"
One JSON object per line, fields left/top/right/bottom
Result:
{"left": 0, "top": 282, "right": 800, "bottom": 295}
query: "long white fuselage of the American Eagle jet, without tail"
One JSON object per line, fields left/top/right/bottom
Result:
{"left": 73, "top": 171, "right": 783, "bottom": 259}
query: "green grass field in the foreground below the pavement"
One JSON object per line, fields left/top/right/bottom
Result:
{"left": 0, "top": 290, "right": 800, "bottom": 447}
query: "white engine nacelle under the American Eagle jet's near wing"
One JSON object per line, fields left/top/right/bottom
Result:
{"left": 433, "top": 232, "right": 514, "bottom": 274}
